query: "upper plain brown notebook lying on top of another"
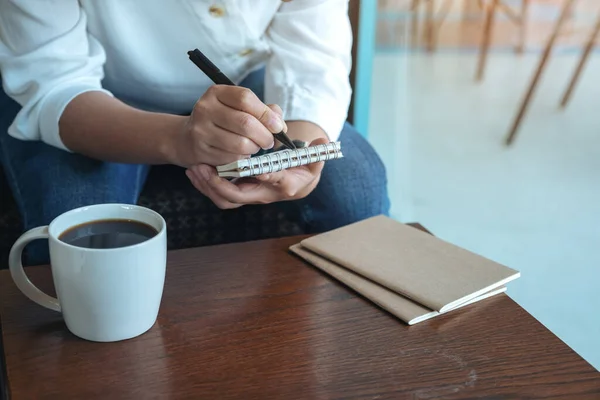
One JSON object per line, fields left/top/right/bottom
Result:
{"left": 301, "top": 215, "right": 520, "bottom": 312}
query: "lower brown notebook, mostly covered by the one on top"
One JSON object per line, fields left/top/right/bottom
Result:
{"left": 290, "top": 244, "right": 506, "bottom": 325}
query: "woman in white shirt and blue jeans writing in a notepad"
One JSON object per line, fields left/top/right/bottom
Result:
{"left": 0, "top": 0, "right": 389, "bottom": 262}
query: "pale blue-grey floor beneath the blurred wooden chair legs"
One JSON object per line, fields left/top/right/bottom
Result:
{"left": 369, "top": 52, "right": 600, "bottom": 369}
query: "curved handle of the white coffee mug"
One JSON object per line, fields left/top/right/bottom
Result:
{"left": 8, "top": 226, "right": 60, "bottom": 312}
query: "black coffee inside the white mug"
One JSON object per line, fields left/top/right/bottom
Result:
{"left": 59, "top": 219, "right": 158, "bottom": 249}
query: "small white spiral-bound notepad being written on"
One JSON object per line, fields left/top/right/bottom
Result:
{"left": 217, "top": 142, "right": 344, "bottom": 178}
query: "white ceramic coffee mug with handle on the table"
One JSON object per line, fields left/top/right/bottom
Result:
{"left": 9, "top": 204, "right": 167, "bottom": 342}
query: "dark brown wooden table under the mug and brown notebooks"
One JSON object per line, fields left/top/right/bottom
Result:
{"left": 0, "top": 227, "right": 600, "bottom": 400}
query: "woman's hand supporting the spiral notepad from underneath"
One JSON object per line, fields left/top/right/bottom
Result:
{"left": 186, "top": 138, "right": 328, "bottom": 209}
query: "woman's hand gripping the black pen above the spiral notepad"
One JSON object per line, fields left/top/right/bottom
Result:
{"left": 173, "top": 85, "right": 287, "bottom": 167}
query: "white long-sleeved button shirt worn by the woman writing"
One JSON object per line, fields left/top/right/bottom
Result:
{"left": 0, "top": 0, "right": 352, "bottom": 151}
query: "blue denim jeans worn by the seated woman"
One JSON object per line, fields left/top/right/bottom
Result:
{"left": 0, "top": 72, "right": 390, "bottom": 264}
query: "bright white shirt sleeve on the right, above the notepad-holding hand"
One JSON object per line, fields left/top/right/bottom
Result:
{"left": 265, "top": 0, "right": 352, "bottom": 141}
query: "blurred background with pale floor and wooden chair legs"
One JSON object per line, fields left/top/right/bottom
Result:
{"left": 357, "top": 0, "right": 600, "bottom": 369}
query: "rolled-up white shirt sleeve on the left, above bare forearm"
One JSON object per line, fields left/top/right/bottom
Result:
{"left": 0, "top": 0, "right": 112, "bottom": 151}
